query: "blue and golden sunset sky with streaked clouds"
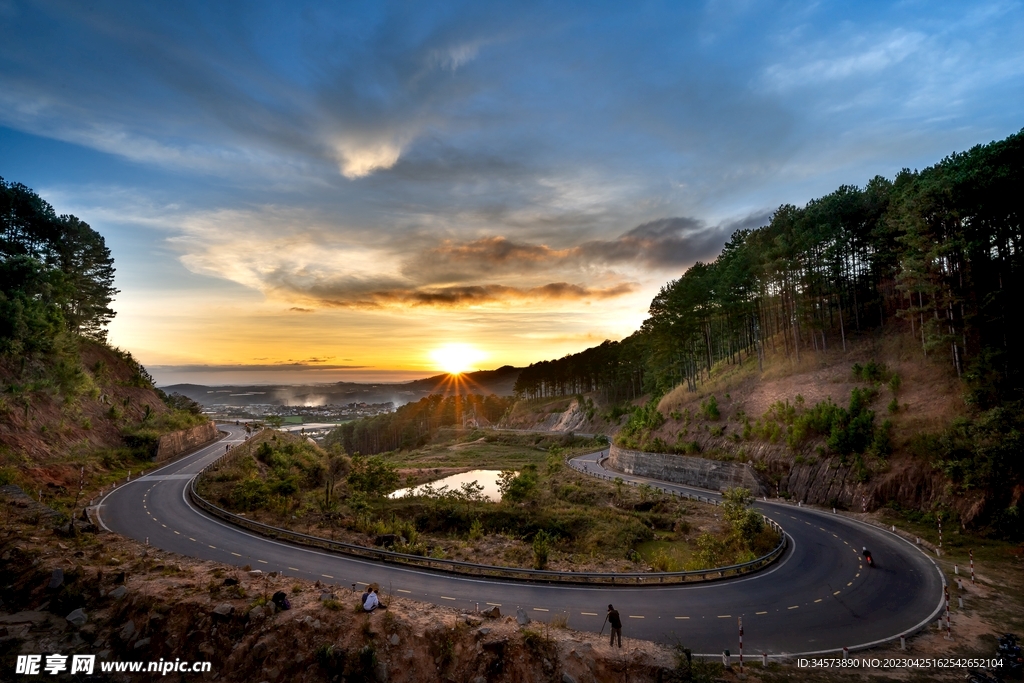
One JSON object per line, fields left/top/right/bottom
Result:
{"left": 0, "top": 0, "right": 1024, "bottom": 385}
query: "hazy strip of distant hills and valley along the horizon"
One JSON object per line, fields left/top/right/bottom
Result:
{"left": 160, "top": 366, "right": 522, "bottom": 407}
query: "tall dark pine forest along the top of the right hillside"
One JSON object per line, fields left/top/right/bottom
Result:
{"left": 515, "top": 131, "right": 1024, "bottom": 409}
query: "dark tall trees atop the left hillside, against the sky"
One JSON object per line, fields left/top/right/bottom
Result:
{"left": 0, "top": 178, "right": 118, "bottom": 355}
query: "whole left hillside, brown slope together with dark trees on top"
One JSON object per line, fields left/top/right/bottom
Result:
{"left": 0, "top": 178, "right": 207, "bottom": 516}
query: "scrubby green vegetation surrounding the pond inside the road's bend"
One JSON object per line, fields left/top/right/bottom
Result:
{"left": 200, "top": 431, "right": 777, "bottom": 570}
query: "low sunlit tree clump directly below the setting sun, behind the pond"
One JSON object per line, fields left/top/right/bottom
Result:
{"left": 324, "top": 394, "right": 511, "bottom": 456}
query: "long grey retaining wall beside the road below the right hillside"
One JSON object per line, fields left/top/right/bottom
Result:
{"left": 605, "top": 444, "right": 767, "bottom": 496}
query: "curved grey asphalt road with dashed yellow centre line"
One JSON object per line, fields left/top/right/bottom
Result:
{"left": 99, "top": 425, "right": 943, "bottom": 655}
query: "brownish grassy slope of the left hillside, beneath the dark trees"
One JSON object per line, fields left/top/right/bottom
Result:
{"left": 0, "top": 337, "right": 209, "bottom": 510}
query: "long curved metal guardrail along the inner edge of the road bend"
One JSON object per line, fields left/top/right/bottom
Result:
{"left": 188, "top": 450, "right": 786, "bottom": 587}
